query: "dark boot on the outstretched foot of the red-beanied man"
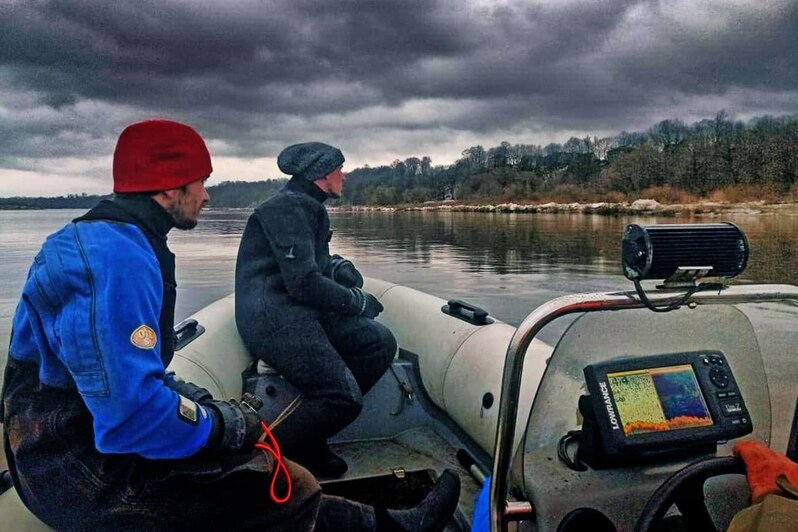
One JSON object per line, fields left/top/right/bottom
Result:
{"left": 375, "top": 469, "right": 460, "bottom": 532}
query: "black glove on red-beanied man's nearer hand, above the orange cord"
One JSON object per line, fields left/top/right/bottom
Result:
{"left": 203, "top": 394, "right": 263, "bottom": 454}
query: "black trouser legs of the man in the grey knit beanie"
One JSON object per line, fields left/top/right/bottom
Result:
{"left": 253, "top": 315, "right": 396, "bottom": 456}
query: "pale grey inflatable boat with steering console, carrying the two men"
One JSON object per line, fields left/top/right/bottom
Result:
{"left": 0, "top": 222, "right": 798, "bottom": 531}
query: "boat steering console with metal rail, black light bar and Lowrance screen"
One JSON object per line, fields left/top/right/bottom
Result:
{"left": 490, "top": 224, "right": 798, "bottom": 532}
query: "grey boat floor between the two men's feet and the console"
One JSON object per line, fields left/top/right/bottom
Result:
{"left": 321, "top": 427, "right": 481, "bottom": 531}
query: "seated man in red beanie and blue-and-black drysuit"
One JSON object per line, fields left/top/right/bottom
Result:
{"left": 0, "top": 120, "right": 459, "bottom": 531}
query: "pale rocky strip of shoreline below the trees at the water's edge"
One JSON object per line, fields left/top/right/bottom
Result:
{"left": 330, "top": 199, "right": 798, "bottom": 216}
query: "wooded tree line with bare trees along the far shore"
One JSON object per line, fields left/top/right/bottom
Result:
{"left": 0, "top": 111, "right": 798, "bottom": 209}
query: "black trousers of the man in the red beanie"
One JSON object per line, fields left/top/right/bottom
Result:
{"left": 3, "top": 359, "right": 384, "bottom": 532}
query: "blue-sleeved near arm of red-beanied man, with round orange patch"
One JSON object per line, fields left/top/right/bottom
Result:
{"left": 61, "top": 222, "right": 219, "bottom": 458}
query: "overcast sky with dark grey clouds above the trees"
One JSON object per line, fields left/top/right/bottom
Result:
{"left": 0, "top": 0, "right": 798, "bottom": 196}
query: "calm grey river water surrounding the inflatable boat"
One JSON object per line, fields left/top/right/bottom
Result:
{"left": 0, "top": 209, "right": 798, "bottom": 448}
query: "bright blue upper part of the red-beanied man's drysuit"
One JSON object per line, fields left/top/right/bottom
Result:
{"left": 9, "top": 197, "right": 212, "bottom": 458}
